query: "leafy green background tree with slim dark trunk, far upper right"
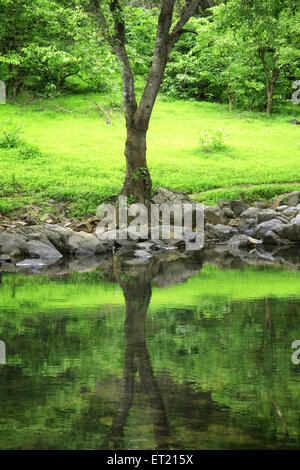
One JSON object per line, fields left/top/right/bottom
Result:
{"left": 214, "top": 0, "right": 300, "bottom": 115}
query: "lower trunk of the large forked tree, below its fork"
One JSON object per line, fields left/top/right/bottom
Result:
{"left": 121, "top": 124, "right": 152, "bottom": 203}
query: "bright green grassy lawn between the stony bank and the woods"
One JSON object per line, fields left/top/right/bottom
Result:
{"left": 0, "top": 90, "right": 300, "bottom": 215}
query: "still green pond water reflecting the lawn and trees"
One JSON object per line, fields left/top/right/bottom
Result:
{"left": 0, "top": 265, "right": 300, "bottom": 449}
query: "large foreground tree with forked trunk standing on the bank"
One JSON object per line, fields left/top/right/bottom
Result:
{"left": 90, "top": 0, "right": 213, "bottom": 203}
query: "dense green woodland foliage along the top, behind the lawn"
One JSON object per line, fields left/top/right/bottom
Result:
{"left": 0, "top": 0, "right": 300, "bottom": 113}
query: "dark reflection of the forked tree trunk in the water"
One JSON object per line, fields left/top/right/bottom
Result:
{"left": 109, "top": 273, "right": 168, "bottom": 449}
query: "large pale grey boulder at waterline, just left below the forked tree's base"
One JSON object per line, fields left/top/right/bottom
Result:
{"left": 66, "top": 232, "right": 112, "bottom": 256}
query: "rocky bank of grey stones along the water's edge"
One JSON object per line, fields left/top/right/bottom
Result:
{"left": 0, "top": 188, "right": 300, "bottom": 268}
